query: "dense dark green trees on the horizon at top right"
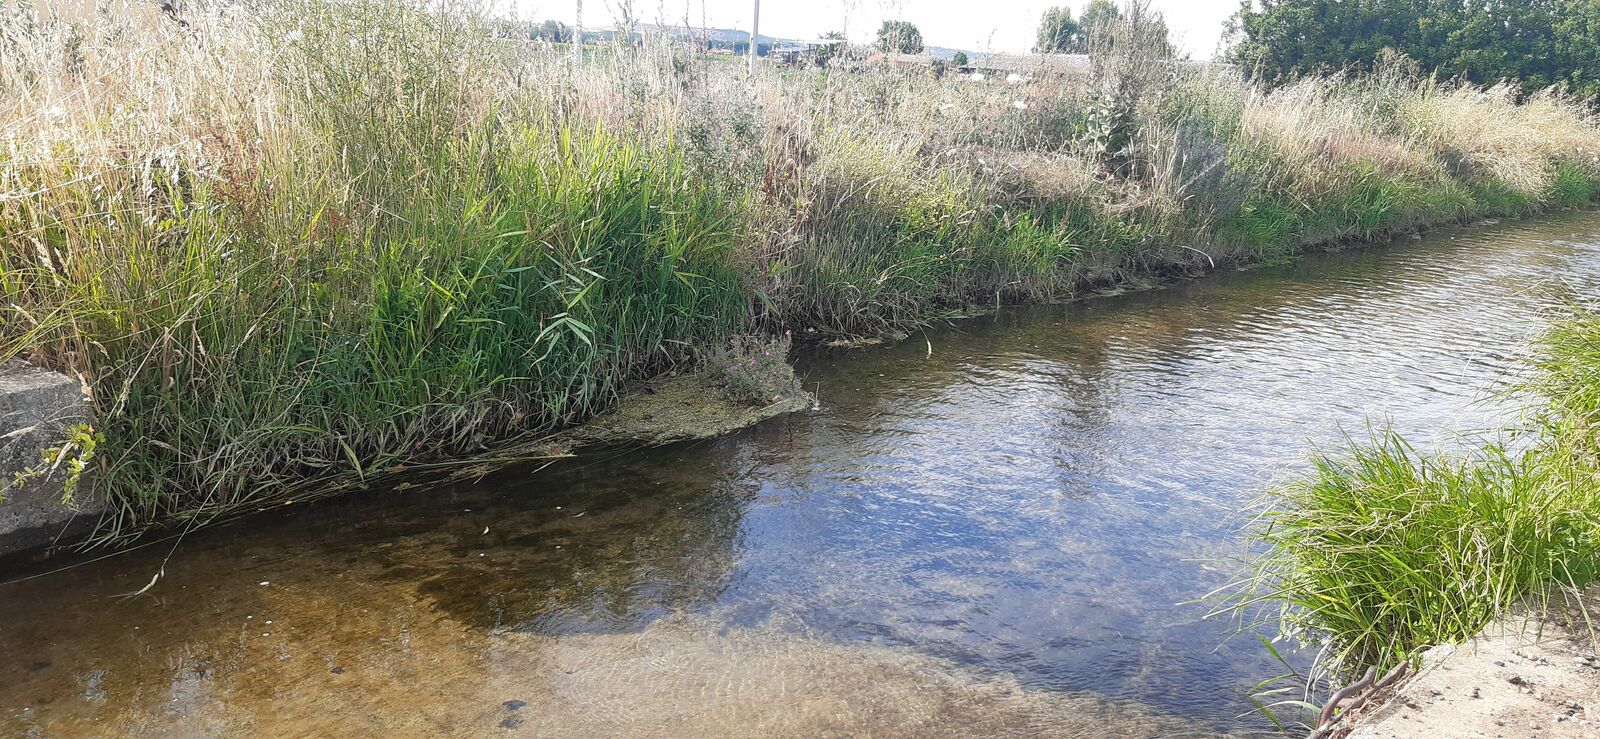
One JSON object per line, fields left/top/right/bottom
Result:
{"left": 1227, "top": 0, "right": 1600, "bottom": 101}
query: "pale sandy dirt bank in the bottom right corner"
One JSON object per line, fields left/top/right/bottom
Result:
{"left": 1330, "top": 589, "right": 1600, "bottom": 739}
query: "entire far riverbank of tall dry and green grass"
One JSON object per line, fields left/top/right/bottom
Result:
{"left": 9, "top": 0, "right": 1600, "bottom": 531}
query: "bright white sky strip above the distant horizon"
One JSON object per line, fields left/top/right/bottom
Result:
{"left": 518, "top": 0, "right": 1238, "bottom": 59}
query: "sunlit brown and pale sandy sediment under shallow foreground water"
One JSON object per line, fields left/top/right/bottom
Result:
{"left": 0, "top": 537, "right": 1192, "bottom": 737}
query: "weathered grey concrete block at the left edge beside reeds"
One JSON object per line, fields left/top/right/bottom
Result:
{"left": 0, "top": 362, "right": 99, "bottom": 555}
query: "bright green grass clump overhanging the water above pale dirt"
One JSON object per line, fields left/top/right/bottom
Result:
{"left": 1246, "top": 309, "right": 1600, "bottom": 710}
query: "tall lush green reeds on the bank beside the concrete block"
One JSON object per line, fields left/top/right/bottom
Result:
{"left": 10, "top": 119, "right": 746, "bottom": 521}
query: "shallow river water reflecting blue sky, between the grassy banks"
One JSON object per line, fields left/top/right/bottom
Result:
{"left": 0, "top": 214, "right": 1600, "bottom": 736}
